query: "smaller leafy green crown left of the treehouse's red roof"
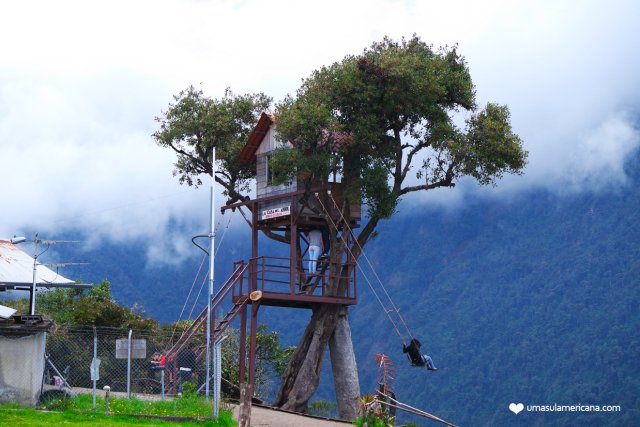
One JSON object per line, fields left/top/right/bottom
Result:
{"left": 153, "top": 86, "right": 271, "bottom": 201}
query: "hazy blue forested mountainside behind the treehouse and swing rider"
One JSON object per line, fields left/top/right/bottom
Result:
{"left": 41, "top": 152, "right": 640, "bottom": 426}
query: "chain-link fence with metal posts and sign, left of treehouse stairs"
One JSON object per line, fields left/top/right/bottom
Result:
{"left": 43, "top": 327, "right": 206, "bottom": 395}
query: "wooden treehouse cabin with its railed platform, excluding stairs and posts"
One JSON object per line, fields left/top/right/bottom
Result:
{"left": 229, "top": 113, "right": 360, "bottom": 308}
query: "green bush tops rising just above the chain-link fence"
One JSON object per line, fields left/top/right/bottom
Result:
{"left": 36, "top": 280, "right": 158, "bottom": 330}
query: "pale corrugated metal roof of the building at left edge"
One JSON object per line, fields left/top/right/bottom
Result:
{"left": 0, "top": 240, "right": 87, "bottom": 289}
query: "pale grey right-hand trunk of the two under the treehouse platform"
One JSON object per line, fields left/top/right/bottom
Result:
{"left": 329, "top": 307, "right": 360, "bottom": 420}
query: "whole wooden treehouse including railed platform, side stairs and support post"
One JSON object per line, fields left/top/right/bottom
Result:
{"left": 169, "top": 113, "right": 361, "bottom": 424}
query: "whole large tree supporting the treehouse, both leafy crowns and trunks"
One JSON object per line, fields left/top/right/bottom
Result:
{"left": 154, "top": 36, "right": 527, "bottom": 418}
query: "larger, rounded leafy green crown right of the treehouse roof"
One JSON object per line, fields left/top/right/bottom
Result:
{"left": 276, "top": 36, "right": 527, "bottom": 224}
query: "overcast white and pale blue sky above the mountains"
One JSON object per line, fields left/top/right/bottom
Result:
{"left": 0, "top": 0, "right": 640, "bottom": 257}
